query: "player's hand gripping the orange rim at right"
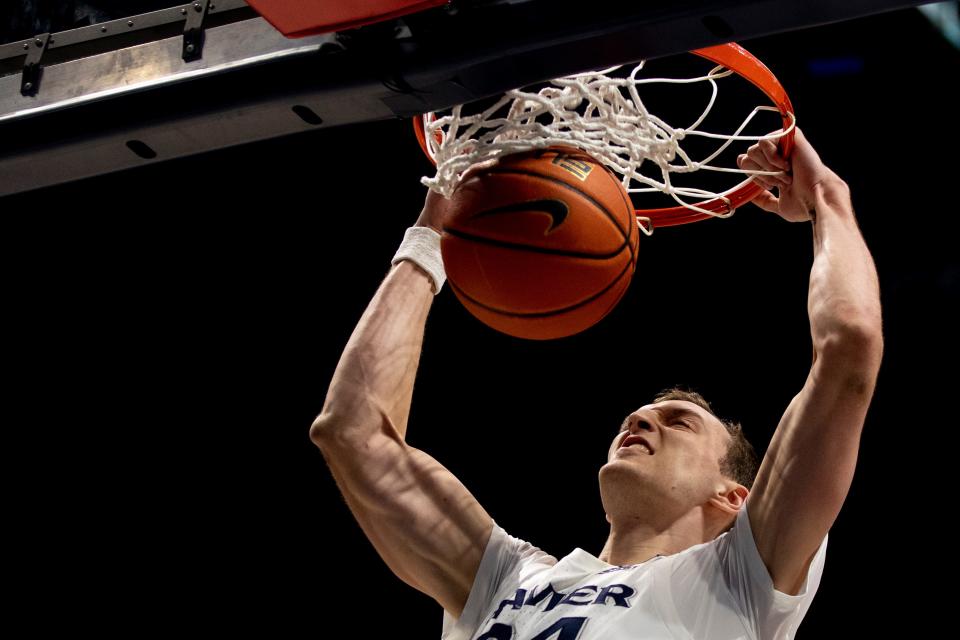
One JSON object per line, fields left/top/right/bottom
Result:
{"left": 737, "top": 127, "right": 843, "bottom": 222}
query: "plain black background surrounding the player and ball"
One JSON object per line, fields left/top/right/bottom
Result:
{"left": 0, "top": 3, "right": 960, "bottom": 638}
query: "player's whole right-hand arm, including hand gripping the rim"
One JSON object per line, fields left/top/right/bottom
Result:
{"left": 747, "top": 134, "right": 883, "bottom": 594}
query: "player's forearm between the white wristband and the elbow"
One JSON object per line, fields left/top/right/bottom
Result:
{"left": 310, "top": 260, "right": 434, "bottom": 444}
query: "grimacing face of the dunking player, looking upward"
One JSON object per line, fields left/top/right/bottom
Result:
{"left": 600, "top": 400, "right": 730, "bottom": 504}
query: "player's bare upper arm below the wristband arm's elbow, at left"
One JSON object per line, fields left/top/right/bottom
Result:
{"left": 320, "top": 418, "right": 493, "bottom": 615}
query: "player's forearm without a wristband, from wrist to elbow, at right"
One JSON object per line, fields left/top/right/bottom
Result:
{"left": 808, "top": 178, "right": 883, "bottom": 369}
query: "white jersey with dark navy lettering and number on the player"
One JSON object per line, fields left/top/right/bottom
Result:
{"left": 441, "top": 499, "right": 827, "bottom": 640}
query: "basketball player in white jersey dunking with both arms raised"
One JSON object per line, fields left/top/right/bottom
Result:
{"left": 311, "top": 129, "right": 883, "bottom": 640}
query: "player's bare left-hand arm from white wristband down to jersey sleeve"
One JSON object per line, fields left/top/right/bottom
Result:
{"left": 310, "top": 225, "right": 493, "bottom": 616}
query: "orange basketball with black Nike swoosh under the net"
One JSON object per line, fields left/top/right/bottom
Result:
{"left": 440, "top": 147, "right": 640, "bottom": 340}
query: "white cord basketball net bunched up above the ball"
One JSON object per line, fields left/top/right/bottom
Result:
{"left": 421, "top": 62, "right": 796, "bottom": 233}
